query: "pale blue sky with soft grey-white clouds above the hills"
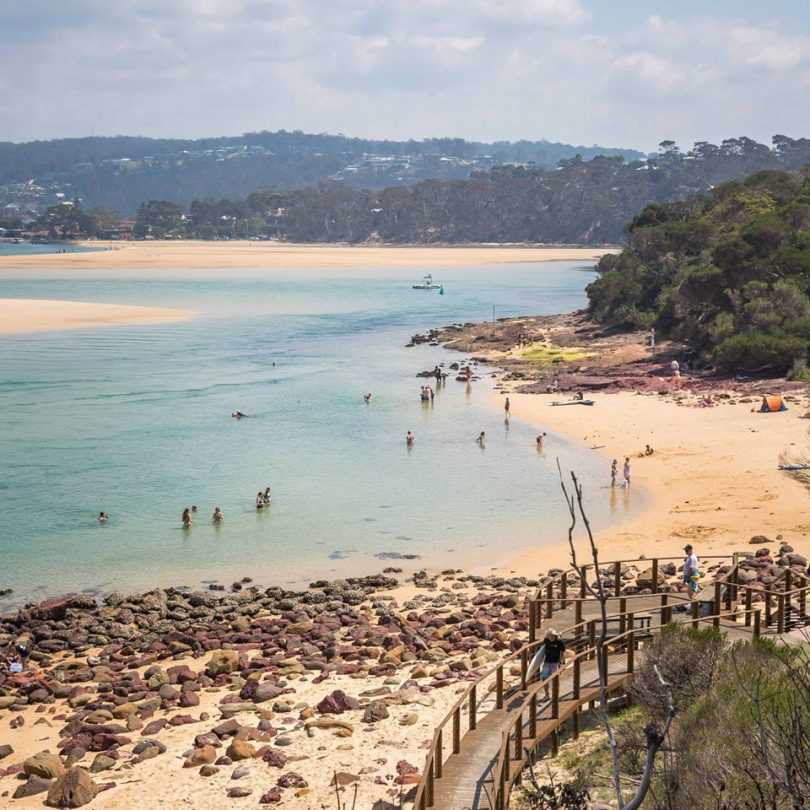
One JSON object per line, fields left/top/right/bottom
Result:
{"left": 0, "top": 0, "right": 810, "bottom": 151}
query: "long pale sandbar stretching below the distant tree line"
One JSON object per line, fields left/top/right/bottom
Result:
{"left": 0, "top": 241, "right": 618, "bottom": 270}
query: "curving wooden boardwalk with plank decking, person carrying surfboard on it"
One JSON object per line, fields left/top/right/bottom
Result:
{"left": 416, "top": 595, "right": 772, "bottom": 810}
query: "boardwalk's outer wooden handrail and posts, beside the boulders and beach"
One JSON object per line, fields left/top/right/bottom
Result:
{"left": 414, "top": 553, "right": 810, "bottom": 810}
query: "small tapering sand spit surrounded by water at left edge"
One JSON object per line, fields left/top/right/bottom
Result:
{"left": 0, "top": 298, "right": 194, "bottom": 335}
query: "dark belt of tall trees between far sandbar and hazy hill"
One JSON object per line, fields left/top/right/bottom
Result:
{"left": 12, "top": 135, "right": 810, "bottom": 245}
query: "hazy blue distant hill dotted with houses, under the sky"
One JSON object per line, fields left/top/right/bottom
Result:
{"left": 0, "top": 130, "right": 642, "bottom": 215}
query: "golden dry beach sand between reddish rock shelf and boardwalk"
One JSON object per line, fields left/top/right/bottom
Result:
{"left": 496, "top": 392, "right": 810, "bottom": 575}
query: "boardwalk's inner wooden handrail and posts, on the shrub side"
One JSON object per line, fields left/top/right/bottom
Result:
{"left": 492, "top": 603, "right": 761, "bottom": 810}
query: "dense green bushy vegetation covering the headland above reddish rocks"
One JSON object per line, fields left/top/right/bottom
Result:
{"left": 588, "top": 169, "right": 810, "bottom": 377}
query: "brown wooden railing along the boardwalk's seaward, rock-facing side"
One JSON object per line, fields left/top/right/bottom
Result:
{"left": 414, "top": 554, "right": 810, "bottom": 810}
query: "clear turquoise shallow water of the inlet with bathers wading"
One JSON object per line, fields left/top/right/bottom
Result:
{"left": 0, "top": 262, "right": 642, "bottom": 606}
